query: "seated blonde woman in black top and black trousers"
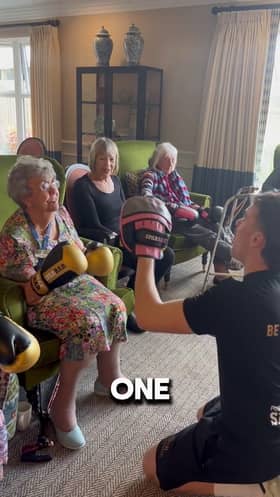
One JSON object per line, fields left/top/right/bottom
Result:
{"left": 71, "top": 138, "right": 174, "bottom": 322}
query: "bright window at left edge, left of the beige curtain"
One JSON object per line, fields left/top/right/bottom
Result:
{"left": 0, "top": 38, "right": 32, "bottom": 154}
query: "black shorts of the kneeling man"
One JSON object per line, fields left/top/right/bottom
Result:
{"left": 156, "top": 397, "right": 280, "bottom": 490}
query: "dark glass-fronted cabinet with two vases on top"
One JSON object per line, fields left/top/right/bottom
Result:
{"left": 76, "top": 65, "right": 162, "bottom": 162}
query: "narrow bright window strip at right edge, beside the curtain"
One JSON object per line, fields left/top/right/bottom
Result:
{"left": 256, "top": 34, "right": 280, "bottom": 186}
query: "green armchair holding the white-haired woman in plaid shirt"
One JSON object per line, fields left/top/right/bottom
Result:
{"left": 116, "top": 140, "right": 211, "bottom": 281}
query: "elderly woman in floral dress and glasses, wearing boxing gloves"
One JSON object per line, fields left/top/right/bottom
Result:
{"left": 0, "top": 156, "right": 126, "bottom": 449}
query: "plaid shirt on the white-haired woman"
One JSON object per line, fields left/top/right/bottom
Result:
{"left": 141, "top": 169, "right": 192, "bottom": 213}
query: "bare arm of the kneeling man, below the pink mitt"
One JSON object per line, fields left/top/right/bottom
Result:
{"left": 135, "top": 257, "right": 192, "bottom": 333}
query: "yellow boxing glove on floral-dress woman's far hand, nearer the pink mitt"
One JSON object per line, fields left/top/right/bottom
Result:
{"left": 86, "top": 241, "right": 114, "bottom": 276}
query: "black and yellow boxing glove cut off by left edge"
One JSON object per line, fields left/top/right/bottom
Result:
{"left": 0, "top": 313, "right": 40, "bottom": 373}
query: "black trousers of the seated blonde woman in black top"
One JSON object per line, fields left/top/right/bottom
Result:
{"left": 120, "top": 247, "right": 175, "bottom": 289}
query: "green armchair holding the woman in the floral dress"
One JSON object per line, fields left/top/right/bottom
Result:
{"left": 0, "top": 155, "right": 134, "bottom": 407}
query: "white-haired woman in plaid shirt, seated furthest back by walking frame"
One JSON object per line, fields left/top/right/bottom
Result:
{"left": 141, "top": 142, "right": 239, "bottom": 283}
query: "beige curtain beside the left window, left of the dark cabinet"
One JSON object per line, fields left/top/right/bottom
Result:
{"left": 30, "top": 26, "right": 61, "bottom": 158}
